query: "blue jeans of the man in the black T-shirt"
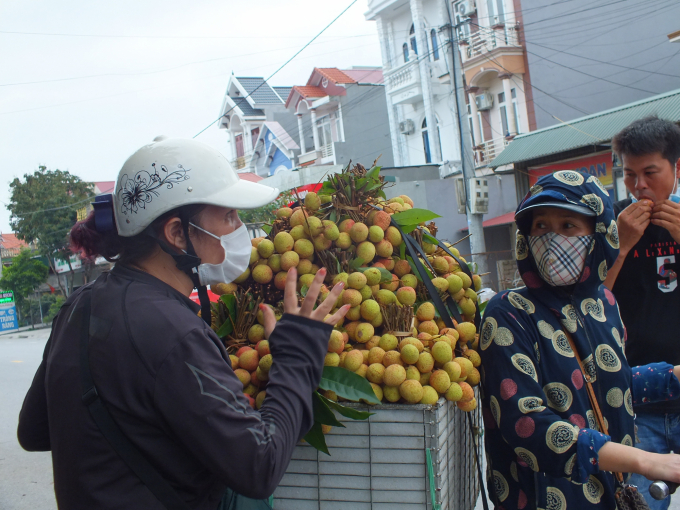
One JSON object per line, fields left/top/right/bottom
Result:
{"left": 628, "top": 413, "right": 680, "bottom": 510}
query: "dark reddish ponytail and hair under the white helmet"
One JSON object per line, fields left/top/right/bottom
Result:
{"left": 69, "top": 197, "right": 205, "bottom": 264}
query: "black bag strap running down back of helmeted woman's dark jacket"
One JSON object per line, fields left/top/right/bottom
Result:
{"left": 75, "top": 290, "right": 190, "bottom": 510}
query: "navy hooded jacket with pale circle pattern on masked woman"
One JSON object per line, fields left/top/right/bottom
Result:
{"left": 479, "top": 171, "right": 634, "bottom": 510}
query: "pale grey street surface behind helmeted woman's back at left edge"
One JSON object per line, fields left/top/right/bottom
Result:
{"left": 0, "top": 328, "right": 57, "bottom": 510}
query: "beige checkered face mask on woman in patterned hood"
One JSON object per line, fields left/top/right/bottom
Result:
{"left": 529, "top": 232, "right": 593, "bottom": 287}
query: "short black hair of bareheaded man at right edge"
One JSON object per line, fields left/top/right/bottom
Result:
{"left": 612, "top": 116, "right": 680, "bottom": 167}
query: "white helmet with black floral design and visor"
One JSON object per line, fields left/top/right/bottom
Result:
{"left": 113, "top": 136, "right": 279, "bottom": 237}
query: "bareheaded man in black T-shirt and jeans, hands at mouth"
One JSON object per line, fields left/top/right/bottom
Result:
{"left": 605, "top": 117, "right": 680, "bottom": 510}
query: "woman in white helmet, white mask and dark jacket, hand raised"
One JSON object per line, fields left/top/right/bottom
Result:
{"left": 18, "top": 138, "right": 346, "bottom": 510}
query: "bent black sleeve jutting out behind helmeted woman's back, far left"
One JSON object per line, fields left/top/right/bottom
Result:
{"left": 17, "top": 337, "right": 51, "bottom": 452}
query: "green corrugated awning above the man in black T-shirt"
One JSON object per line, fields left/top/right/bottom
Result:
{"left": 489, "top": 89, "right": 680, "bottom": 168}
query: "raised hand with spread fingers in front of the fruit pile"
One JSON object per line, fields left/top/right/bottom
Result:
{"left": 260, "top": 268, "right": 350, "bottom": 338}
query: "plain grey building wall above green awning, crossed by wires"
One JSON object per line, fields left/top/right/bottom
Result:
{"left": 521, "top": 0, "right": 680, "bottom": 129}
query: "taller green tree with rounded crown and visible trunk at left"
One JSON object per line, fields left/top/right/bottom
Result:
{"left": 7, "top": 166, "right": 93, "bottom": 296}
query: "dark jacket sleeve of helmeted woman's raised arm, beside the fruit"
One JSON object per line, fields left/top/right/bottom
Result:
{"left": 154, "top": 315, "right": 332, "bottom": 499}
